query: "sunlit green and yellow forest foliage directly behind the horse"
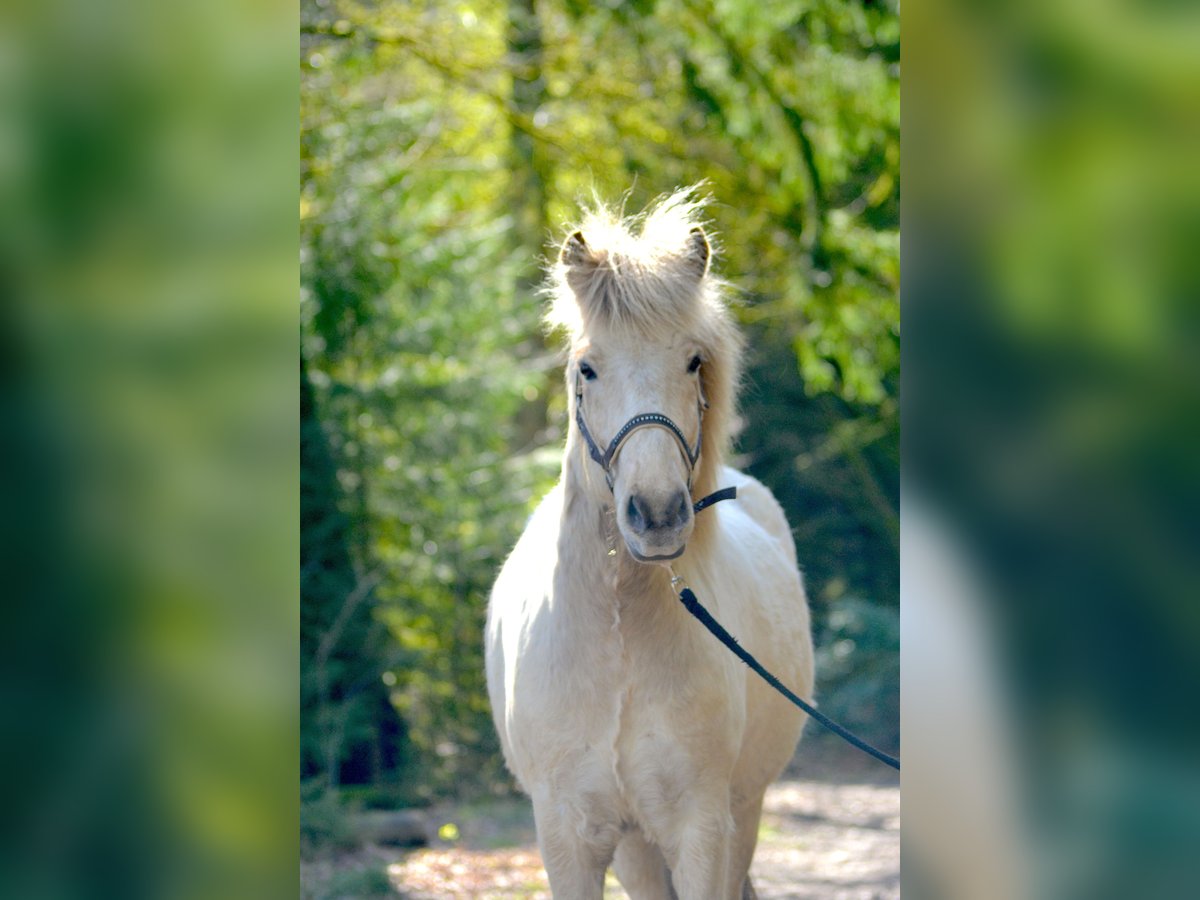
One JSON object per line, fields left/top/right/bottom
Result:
{"left": 300, "top": 0, "right": 899, "bottom": 796}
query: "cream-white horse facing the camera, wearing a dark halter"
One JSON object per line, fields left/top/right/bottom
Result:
{"left": 486, "top": 191, "right": 812, "bottom": 900}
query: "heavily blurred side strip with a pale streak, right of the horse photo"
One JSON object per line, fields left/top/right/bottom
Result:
{"left": 901, "top": 0, "right": 1200, "bottom": 898}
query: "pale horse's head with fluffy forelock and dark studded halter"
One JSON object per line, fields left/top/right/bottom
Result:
{"left": 552, "top": 192, "right": 739, "bottom": 563}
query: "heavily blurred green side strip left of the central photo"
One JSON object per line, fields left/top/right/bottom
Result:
{"left": 0, "top": 0, "right": 300, "bottom": 900}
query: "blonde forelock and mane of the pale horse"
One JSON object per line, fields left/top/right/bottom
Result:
{"left": 546, "top": 187, "right": 743, "bottom": 497}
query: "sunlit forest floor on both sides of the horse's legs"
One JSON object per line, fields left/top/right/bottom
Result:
{"left": 301, "top": 751, "right": 900, "bottom": 900}
